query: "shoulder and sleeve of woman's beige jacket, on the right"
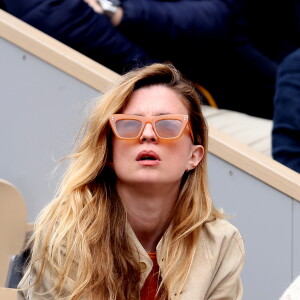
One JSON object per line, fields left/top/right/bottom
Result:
{"left": 189, "top": 218, "right": 245, "bottom": 300}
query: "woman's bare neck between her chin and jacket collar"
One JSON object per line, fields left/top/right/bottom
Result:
{"left": 117, "top": 182, "right": 179, "bottom": 253}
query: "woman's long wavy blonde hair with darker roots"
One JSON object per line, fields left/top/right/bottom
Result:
{"left": 28, "top": 64, "right": 222, "bottom": 300}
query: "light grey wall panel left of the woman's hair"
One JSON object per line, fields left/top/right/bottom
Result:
{"left": 0, "top": 39, "right": 98, "bottom": 221}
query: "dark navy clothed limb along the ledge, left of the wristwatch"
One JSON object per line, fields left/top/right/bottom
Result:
{"left": 2, "top": 0, "right": 156, "bottom": 73}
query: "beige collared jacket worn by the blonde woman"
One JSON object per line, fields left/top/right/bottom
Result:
{"left": 17, "top": 219, "right": 245, "bottom": 300}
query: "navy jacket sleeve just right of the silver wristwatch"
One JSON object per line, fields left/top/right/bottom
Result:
{"left": 120, "top": 0, "right": 232, "bottom": 42}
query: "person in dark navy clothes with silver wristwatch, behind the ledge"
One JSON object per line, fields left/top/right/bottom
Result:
{"left": 0, "top": 0, "right": 277, "bottom": 118}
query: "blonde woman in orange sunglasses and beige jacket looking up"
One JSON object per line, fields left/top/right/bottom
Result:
{"left": 19, "top": 64, "right": 244, "bottom": 300}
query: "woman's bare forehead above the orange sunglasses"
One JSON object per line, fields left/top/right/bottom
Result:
{"left": 123, "top": 85, "right": 188, "bottom": 115}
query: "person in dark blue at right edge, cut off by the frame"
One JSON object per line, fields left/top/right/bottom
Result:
{"left": 272, "top": 49, "right": 300, "bottom": 173}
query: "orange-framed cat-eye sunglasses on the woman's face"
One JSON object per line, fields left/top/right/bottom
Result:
{"left": 109, "top": 114, "right": 194, "bottom": 142}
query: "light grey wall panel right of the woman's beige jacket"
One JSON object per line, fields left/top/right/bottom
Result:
{"left": 208, "top": 155, "right": 300, "bottom": 300}
